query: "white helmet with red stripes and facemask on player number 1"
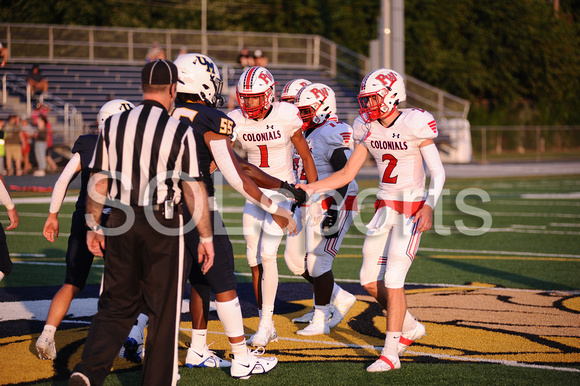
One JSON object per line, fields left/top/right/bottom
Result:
{"left": 236, "top": 66, "right": 276, "bottom": 119}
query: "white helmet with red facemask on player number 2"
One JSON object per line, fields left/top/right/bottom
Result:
{"left": 358, "top": 68, "right": 407, "bottom": 123}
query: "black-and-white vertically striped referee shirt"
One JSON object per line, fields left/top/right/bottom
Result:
{"left": 89, "top": 100, "right": 199, "bottom": 206}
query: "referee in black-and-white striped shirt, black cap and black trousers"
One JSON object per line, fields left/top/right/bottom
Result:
{"left": 69, "top": 60, "right": 214, "bottom": 386}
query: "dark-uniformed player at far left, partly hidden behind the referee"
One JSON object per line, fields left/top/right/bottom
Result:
{"left": 36, "top": 99, "right": 135, "bottom": 360}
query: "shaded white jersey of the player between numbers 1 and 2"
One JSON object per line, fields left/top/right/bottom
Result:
{"left": 294, "top": 119, "right": 358, "bottom": 195}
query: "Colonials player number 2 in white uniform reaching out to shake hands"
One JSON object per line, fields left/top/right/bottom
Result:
{"left": 302, "top": 68, "right": 445, "bottom": 372}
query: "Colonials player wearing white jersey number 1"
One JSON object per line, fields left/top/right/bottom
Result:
{"left": 228, "top": 66, "right": 317, "bottom": 347}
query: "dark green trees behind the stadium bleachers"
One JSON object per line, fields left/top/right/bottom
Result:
{"left": 0, "top": 0, "right": 580, "bottom": 125}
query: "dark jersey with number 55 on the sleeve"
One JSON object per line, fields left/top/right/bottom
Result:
{"left": 171, "top": 101, "right": 235, "bottom": 196}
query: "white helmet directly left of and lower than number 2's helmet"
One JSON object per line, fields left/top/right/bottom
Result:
{"left": 294, "top": 83, "right": 336, "bottom": 130}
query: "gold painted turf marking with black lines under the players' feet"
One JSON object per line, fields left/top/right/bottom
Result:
{"left": 0, "top": 283, "right": 580, "bottom": 385}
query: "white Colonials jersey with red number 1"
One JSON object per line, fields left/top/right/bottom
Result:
{"left": 228, "top": 102, "right": 302, "bottom": 184}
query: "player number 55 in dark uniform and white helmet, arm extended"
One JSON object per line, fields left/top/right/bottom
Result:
{"left": 172, "top": 54, "right": 296, "bottom": 378}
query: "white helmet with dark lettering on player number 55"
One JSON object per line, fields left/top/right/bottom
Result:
{"left": 174, "top": 54, "right": 224, "bottom": 108}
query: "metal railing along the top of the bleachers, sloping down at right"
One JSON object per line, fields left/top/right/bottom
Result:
{"left": 0, "top": 23, "right": 469, "bottom": 118}
